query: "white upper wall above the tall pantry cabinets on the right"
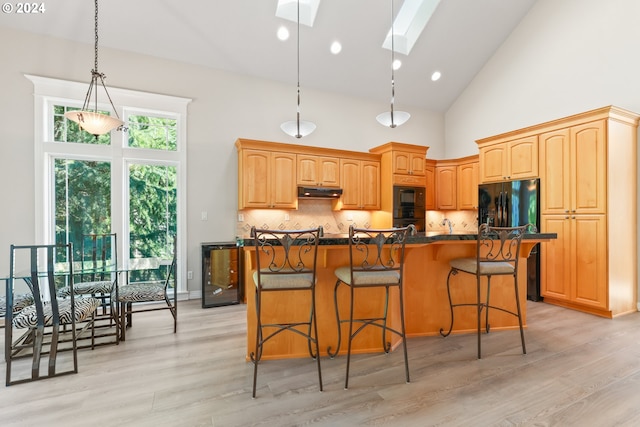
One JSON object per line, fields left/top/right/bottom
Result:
{"left": 445, "top": 0, "right": 640, "bottom": 158}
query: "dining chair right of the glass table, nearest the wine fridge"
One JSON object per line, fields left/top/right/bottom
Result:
{"left": 112, "top": 237, "right": 178, "bottom": 341}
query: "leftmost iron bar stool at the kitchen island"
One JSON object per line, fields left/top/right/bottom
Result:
{"left": 250, "top": 226, "right": 322, "bottom": 398}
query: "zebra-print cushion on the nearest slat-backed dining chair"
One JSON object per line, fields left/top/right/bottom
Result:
{"left": 13, "top": 297, "right": 100, "bottom": 328}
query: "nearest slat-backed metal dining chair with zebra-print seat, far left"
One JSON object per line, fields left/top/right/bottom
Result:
{"left": 5, "top": 243, "right": 100, "bottom": 386}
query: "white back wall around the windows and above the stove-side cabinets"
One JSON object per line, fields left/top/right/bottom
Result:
{"left": 0, "top": 28, "right": 444, "bottom": 292}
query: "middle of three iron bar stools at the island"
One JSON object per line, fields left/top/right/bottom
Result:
{"left": 328, "top": 225, "right": 416, "bottom": 389}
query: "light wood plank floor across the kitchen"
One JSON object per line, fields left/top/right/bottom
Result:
{"left": 0, "top": 301, "right": 640, "bottom": 427}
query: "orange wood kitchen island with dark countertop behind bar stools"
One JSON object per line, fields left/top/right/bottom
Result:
{"left": 243, "top": 232, "right": 556, "bottom": 359}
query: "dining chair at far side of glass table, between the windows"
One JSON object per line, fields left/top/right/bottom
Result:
{"left": 58, "top": 233, "right": 119, "bottom": 348}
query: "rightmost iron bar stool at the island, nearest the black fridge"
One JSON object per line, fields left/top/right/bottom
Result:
{"left": 440, "top": 224, "right": 535, "bottom": 359}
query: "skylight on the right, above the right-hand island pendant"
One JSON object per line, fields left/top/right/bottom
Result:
{"left": 380, "top": 0, "right": 440, "bottom": 55}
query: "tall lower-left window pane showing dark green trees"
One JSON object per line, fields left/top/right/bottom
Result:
{"left": 54, "top": 159, "right": 111, "bottom": 259}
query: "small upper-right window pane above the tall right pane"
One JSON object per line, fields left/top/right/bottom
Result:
{"left": 128, "top": 115, "right": 178, "bottom": 151}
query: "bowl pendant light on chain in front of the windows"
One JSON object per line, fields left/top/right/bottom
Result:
{"left": 64, "top": 0, "right": 126, "bottom": 139}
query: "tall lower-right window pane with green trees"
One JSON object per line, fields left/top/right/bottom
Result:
{"left": 129, "top": 165, "right": 177, "bottom": 281}
